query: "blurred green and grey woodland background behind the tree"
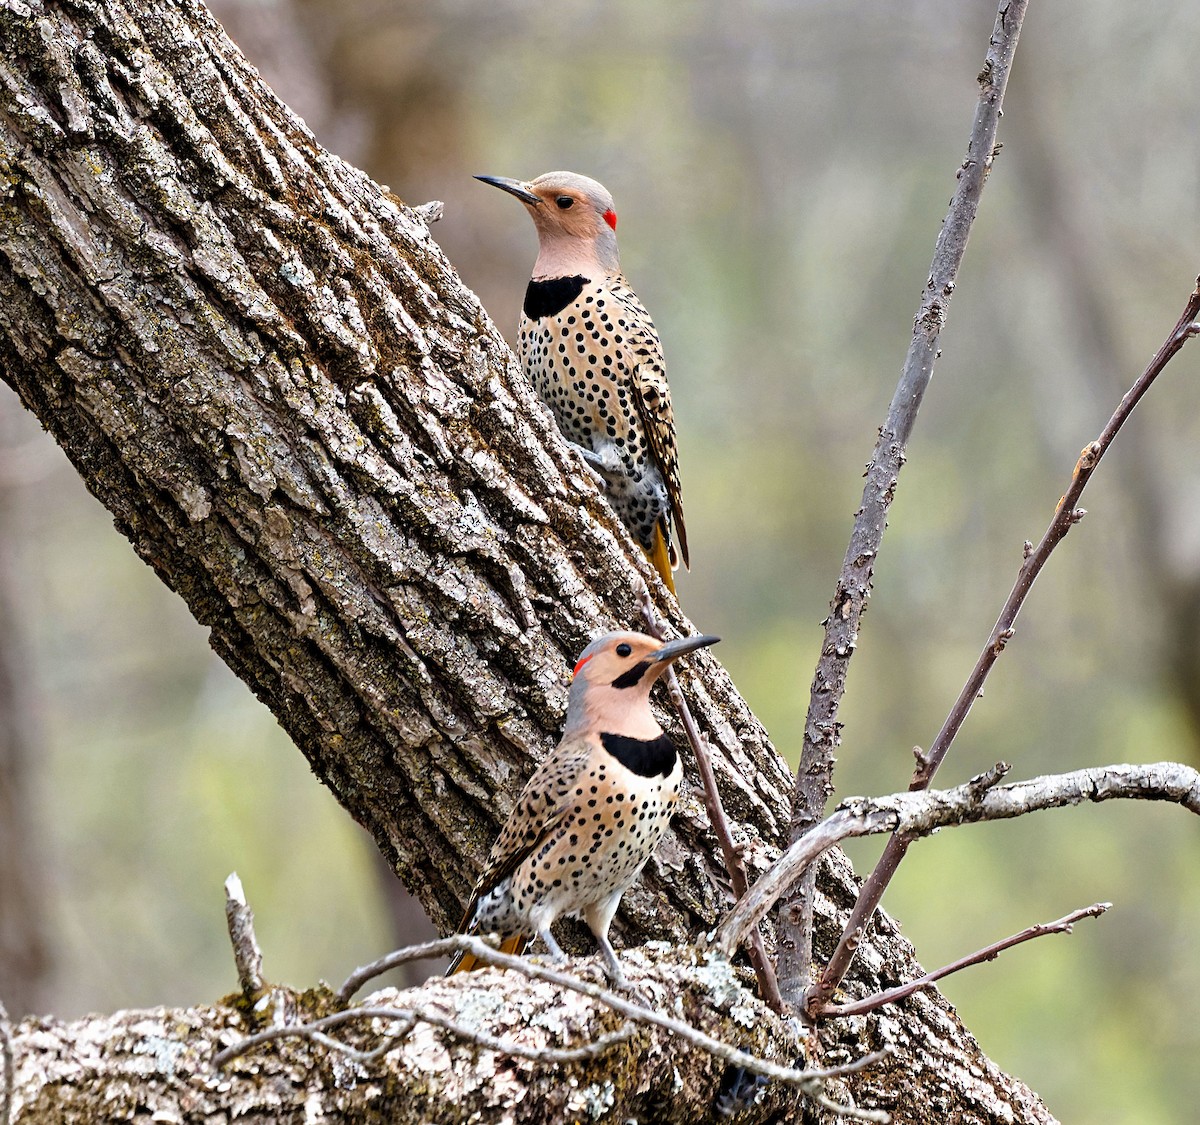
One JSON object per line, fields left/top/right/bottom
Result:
{"left": 0, "top": 0, "right": 1200, "bottom": 1125}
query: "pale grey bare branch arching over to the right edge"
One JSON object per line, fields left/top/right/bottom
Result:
{"left": 713, "top": 762, "right": 1200, "bottom": 956}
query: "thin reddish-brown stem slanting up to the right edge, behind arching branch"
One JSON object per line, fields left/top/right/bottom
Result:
{"left": 804, "top": 278, "right": 1200, "bottom": 1010}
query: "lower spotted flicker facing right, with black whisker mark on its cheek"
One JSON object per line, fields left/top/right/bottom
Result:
{"left": 446, "top": 633, "right": 720, "bottom": 983}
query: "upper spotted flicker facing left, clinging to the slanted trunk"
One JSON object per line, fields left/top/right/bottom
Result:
{"left": 475, "top": 172, "right": 688, "bottom": 592}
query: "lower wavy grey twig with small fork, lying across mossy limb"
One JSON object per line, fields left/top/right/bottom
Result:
{"left": 212, "top": 1007, "right": 637, "bottom": 1067}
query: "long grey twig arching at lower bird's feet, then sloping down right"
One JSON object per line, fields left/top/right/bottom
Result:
{"left": 337, "top": 933, "right": 887, "bottom": 1091}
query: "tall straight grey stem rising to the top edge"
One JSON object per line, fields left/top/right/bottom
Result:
{"left": 776, "top": 0, "right": 1027, "bottom": 1015}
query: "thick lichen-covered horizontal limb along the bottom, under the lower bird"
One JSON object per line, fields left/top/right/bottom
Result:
{"left": 13, "top": 945, "right": 883, "bottom": 1125}
